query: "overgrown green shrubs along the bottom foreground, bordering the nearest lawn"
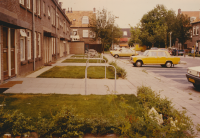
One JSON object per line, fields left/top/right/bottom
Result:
{"left": 0, "top": 86, "right": 199, "bottom": 138}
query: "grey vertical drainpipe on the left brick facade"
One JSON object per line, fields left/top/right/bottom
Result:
{"left": 32, "top": 0, "right": 36, "bottom": 71}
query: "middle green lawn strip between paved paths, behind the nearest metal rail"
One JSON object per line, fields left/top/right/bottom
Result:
{"left": 38, "top": 66, "right": 115, "bottom": 79}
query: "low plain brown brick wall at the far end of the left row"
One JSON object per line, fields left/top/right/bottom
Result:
{"left": 69, "top": 42, "right": 85, "bottom": 54}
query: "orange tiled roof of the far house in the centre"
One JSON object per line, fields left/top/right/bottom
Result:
{"left": 66, "top": 11, "right": 95, "bottom": 27}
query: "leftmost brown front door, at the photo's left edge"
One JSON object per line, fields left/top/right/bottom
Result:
{"left": 3, "top": 27, "right": 8, "bottom": 80}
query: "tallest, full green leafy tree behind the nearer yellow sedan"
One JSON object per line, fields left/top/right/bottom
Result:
{"left": 140, "top": 5, "right": 175, "bottom": 47}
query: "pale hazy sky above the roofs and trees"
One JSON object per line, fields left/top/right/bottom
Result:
{"left": 59, "top": 0, "right": 200, "bottom": 28}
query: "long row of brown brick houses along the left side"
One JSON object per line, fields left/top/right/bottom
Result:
{"left": 0, "top": 0, "right": 70, "bottom": 83}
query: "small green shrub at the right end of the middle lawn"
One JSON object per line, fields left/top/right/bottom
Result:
{"left": 109, "top": 61, "right": 126, "bottom": 79}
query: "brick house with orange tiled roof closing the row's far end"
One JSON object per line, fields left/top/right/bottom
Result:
{"left": 66, "top": 8, "right": 100, "bottom": 54}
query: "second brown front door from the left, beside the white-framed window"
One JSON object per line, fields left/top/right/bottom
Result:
{"left": 10, "top": 29, "right": 15, "bottom": 77}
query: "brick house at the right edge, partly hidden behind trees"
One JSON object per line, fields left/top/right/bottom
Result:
{"left": 178, "top": 9, "right": 200, "bottom": 49}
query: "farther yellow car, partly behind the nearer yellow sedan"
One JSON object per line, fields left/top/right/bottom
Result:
{"left": 111, "top": 48, "right": 138, "bottom": 58}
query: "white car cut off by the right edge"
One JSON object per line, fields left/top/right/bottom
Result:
{"left": 186, "top": 66, "right": 200, "bottom": 89}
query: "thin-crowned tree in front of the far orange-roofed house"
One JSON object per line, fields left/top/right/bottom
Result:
{"left": 89, "top": 9, "right": 122, "bottom": 52}
